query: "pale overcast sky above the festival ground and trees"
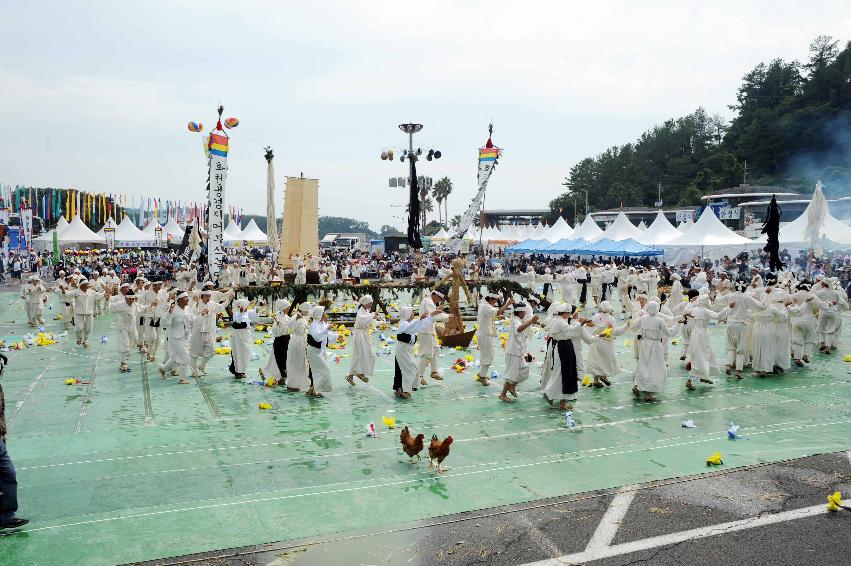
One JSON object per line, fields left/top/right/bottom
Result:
{"left": 0, "top": 0, "right": 851, "bottom": 229}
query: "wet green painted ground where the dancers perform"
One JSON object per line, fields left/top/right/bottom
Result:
{"left": 0, "top": 293, "right": 851, "bottom": 565}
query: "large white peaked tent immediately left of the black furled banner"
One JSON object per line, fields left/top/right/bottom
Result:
{"left": 659, "top": 206, "right": 762, "bottom": 264}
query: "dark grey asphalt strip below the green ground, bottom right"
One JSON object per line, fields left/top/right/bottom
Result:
{"left": 143, "top": 452, "right": 851, "bottom": 566}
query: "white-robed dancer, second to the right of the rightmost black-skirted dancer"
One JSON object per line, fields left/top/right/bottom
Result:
{"left": 631, "top": 301, "right": 678, "bottom": 401}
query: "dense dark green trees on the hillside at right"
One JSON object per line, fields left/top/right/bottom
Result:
{"left": 548, "top": 36, "right": 851, "bottom": 225}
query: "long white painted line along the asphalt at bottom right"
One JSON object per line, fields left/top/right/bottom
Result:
{"left": 524, "top": 504, "right": 828, "bottom": 566}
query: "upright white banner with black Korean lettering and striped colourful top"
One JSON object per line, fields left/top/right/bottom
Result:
{"left": 207, "top": 132, "right": 229, "bottom": 281}
